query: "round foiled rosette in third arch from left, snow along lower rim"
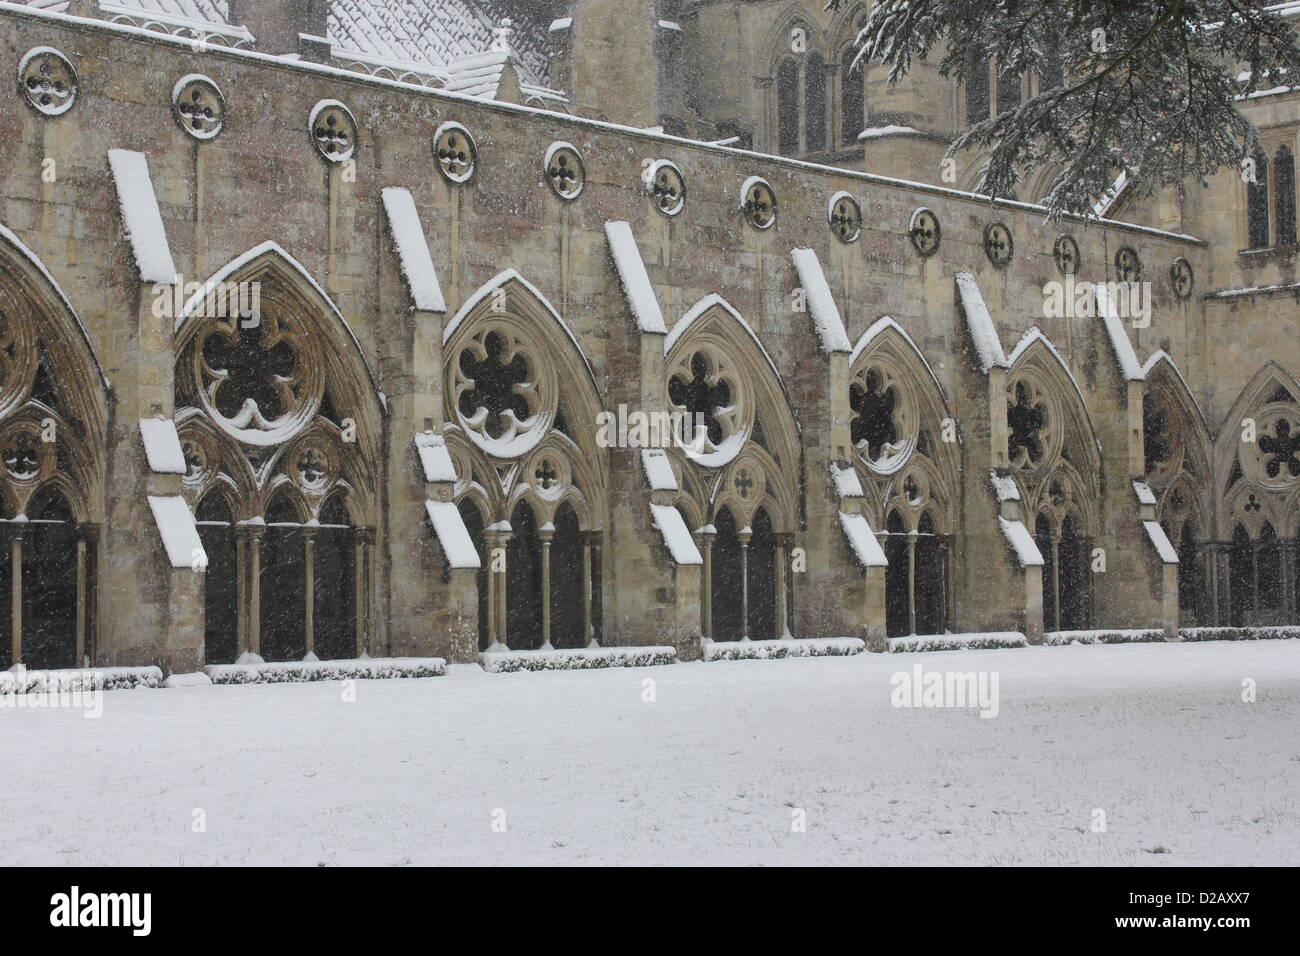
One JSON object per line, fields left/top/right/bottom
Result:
{"left": 447, "top": 321, "right": 559, "bottom": 459}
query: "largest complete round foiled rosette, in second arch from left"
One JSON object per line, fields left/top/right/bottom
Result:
{"left": 192, "top": 312, "right": 325, "bottom": 446}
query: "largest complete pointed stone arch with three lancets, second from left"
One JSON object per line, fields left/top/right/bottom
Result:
{"left": 176, "top": 242, "right": 384, "bottom": 662}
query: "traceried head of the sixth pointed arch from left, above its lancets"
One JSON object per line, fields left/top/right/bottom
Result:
{"left": 1006, "top": 328, "right": 1101, "bottom": 536}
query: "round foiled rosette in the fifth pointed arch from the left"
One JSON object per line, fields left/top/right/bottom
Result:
{"left": 849, "top": 359, "right": 920, "bottom": 475}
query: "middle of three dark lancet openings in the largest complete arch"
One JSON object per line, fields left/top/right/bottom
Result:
{"left": 259, "top": 492, "right": 307, "bottom": 661}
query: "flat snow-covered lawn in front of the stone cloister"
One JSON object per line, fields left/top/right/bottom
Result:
{"left": 0, "top": 641, "right": 1300, "bottom": 865}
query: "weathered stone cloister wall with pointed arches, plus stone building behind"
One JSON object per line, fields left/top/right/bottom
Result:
{"left": 0, "top": 0, "right": 1300, "bottom": 671}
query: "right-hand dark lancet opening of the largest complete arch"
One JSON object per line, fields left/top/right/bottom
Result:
{"left": 312, "top": 493, "right": 358, "bottom": 661}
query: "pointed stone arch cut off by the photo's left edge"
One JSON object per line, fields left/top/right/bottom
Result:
{"left": 0, "top": 226, "right": 108, "bottom": 669}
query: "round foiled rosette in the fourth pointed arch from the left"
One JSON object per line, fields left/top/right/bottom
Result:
{"left": 666, "top": 338, "right": 754, "bottom": 468}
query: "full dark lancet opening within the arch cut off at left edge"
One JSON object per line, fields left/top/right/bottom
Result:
{"left": 22, "top": 485, "right": 81, "bottom": 670}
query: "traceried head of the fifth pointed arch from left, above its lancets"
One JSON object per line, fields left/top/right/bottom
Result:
{"left": 849, "top": 316, "right": 961, "bottom": 535}
